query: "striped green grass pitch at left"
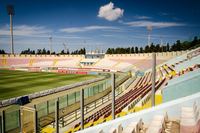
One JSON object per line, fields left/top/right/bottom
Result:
{"left": 0, "top": 69, "right": 97, "bottom": 100}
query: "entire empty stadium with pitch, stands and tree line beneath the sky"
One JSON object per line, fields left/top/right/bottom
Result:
{"left": 0, "top": 0, "right": 200, "bottom": 133}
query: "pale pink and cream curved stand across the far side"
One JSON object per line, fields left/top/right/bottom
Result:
{"left": 0, "top": 51, "right": 187, "bottom": 71}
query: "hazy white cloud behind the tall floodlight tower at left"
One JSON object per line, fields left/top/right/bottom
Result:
{"left": 0, "top": 25, "right": 52, "bottom": 36}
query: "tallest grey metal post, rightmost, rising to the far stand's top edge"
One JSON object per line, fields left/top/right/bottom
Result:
{"left": 151, "top": 53, "right": 156, "bottom": 107}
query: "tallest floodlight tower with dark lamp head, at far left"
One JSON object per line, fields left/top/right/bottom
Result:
{"left": 7, "top": 5, "right": 15, "bottom": 54}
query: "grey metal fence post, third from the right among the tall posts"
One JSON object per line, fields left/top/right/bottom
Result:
{"left": 80, "top": 89, "right": 84, "bottom": 130}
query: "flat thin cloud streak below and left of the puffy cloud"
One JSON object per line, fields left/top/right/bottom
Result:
{"left": 59, "top": 25, "right": 119, "bottom": 33}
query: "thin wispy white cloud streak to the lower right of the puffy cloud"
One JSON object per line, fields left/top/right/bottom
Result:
{"left": 123, "top": 20, "right": 185, "bottom": 28}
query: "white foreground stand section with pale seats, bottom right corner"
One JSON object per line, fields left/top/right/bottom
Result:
{"left": 76, "top": 93, "right": 200, "bottom": 133}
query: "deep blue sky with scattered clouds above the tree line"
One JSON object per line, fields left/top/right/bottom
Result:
{"left": 0, "top": 0, "right": 200, "bottom": 52}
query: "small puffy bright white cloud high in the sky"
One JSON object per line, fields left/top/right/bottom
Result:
{"left": 98, "top": 2, "right": 124, "bottom": 21}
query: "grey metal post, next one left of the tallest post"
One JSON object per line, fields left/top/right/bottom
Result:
{"left": 111, "top": 73, "right": 115, "bottom": 119}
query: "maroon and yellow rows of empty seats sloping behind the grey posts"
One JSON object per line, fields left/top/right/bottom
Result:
{"left": 62, "top": 49, "right": 198, "bottom": 132}
